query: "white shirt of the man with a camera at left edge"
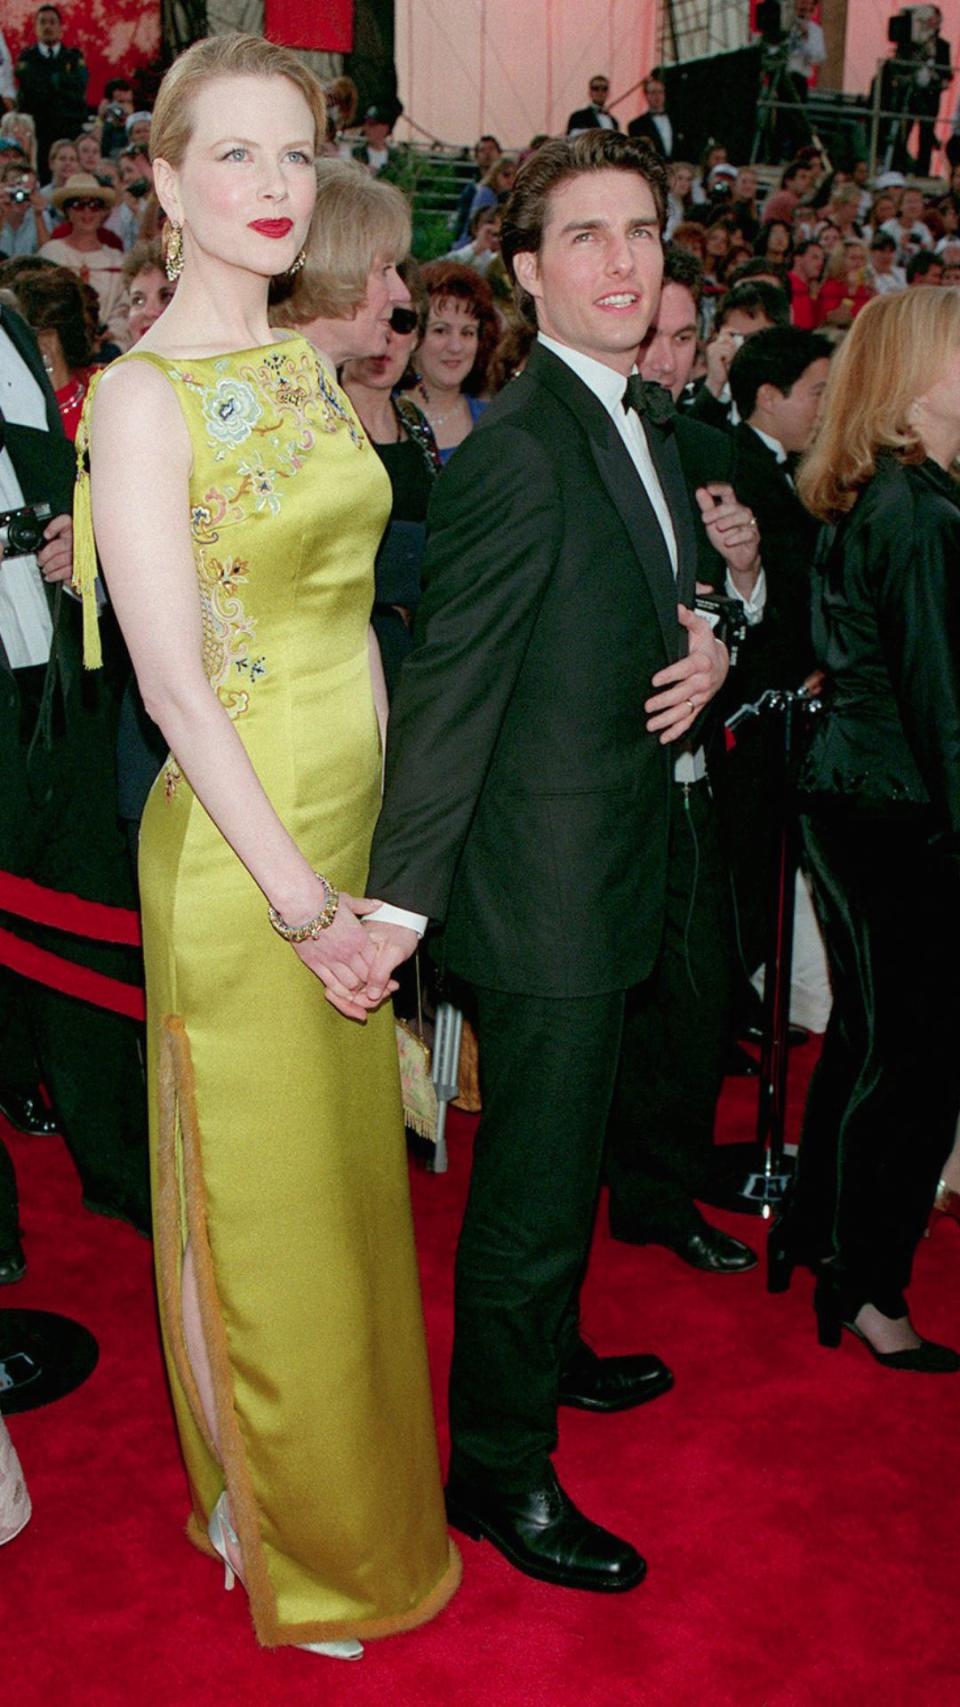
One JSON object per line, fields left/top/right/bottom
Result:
{"left": 0, "top": 328, "right": 53, "bottom": 669}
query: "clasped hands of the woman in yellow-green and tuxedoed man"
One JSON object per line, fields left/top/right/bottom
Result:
{"left": 294, "top": 889, "right": 419, "bottom": 1024}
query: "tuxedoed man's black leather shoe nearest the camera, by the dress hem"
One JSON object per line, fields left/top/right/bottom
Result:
{"left": 446, "top": 1470, "right": 647, "bottom": 1594}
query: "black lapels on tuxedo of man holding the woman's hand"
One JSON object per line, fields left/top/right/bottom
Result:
{"left": 528, "top": 343, "right": 692, "bottom": 661}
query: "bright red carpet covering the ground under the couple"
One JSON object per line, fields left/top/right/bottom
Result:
{"left": 0, "top": 1050, "right": 960, "bottom": 1707}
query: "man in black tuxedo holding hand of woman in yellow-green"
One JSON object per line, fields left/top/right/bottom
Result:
{"left": 351, "top": 130, "right": 750, "bottom": 1591}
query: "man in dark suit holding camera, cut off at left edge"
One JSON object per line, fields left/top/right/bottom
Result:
{"left": 0, "top": 307, "right": 149, "bottom": 1279}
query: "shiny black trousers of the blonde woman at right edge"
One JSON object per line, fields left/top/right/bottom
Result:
{"left": 789, "top": 802, "right": 960, "bottom": 1316}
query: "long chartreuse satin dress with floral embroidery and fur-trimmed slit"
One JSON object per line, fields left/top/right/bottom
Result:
{"left": 78, "top": 336, "right": 460, "bottom": 1644}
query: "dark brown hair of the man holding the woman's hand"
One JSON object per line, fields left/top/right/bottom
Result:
{"left": 500, "top": 130, "right": 666, "bottom": 314}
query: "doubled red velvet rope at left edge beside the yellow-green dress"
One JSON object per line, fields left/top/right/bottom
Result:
{"left": 0, "top": 871, "right": 145, "bottom": 1019}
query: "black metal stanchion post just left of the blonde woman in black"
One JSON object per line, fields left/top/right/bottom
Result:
{"left": 705, "top": 688, "right": 823, "bottom": 1219}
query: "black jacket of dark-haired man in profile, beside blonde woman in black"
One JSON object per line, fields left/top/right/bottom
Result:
{"left": 733, "top": 422, "right": 820, "bottom": 698}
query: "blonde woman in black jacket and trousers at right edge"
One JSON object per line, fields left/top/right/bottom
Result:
{"left": 769, "top": 287, "right": 960, "bottom": 1372}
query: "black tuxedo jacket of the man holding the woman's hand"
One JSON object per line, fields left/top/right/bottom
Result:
{"left": 367, "top": 345, "right": 697, "bottom": 997}
